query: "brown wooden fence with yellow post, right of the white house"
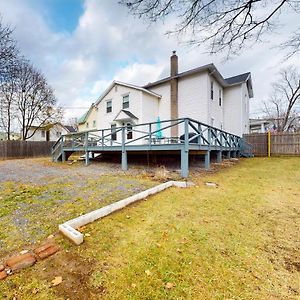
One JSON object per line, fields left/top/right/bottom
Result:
{"left": 244, "top": 133, "right": 300, "bottom": 156}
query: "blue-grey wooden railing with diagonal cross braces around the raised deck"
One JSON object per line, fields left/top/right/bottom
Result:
{"left": 52, "top": 118, "right": 242, "bottom": 153}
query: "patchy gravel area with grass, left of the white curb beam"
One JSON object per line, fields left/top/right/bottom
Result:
{"left": 0, "top": 158, "right": 161, "bottom": 258}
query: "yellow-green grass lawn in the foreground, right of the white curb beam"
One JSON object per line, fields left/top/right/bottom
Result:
{"left": 0, "top": 158, "right": 300, "bottom": 299}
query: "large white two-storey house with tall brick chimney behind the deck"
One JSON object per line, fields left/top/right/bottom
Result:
{"left": 78, "top": 51, "right": 253, "bottom": 139}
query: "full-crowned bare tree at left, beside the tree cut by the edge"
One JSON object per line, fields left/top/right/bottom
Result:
{"left": 17, "top": 61, "right": 62, "bottom": 140}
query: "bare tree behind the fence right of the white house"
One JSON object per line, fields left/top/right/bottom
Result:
{"left": 264, "top": 67, "right": 300, "bottom": 131}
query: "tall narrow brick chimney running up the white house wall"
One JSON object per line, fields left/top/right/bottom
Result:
{"left": 170, "top": 51, "right": 178, "bottom": 137}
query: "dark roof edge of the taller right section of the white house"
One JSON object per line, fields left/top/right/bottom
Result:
{"left": 143, "top": 63, "right": 253, "bottom": 98}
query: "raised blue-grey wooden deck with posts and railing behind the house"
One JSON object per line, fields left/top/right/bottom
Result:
{"left": 52, "top": 118, "right": 251, "bottom": 178}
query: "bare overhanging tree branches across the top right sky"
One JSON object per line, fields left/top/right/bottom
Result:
{"left": 119, "top": 0, "right": 300, "bottom": 57}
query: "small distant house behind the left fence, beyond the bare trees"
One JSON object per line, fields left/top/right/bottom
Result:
{"left": 28, "top": 123, "right": 76, "bottom": 142}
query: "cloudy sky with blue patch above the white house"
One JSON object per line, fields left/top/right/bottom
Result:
{"left": 0, "top": 0, "right": 300, "bottom": 119}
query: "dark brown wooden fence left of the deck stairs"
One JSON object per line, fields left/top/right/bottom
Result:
{"left": 0, "top": 141, "right": 54, "bottom": 159}
